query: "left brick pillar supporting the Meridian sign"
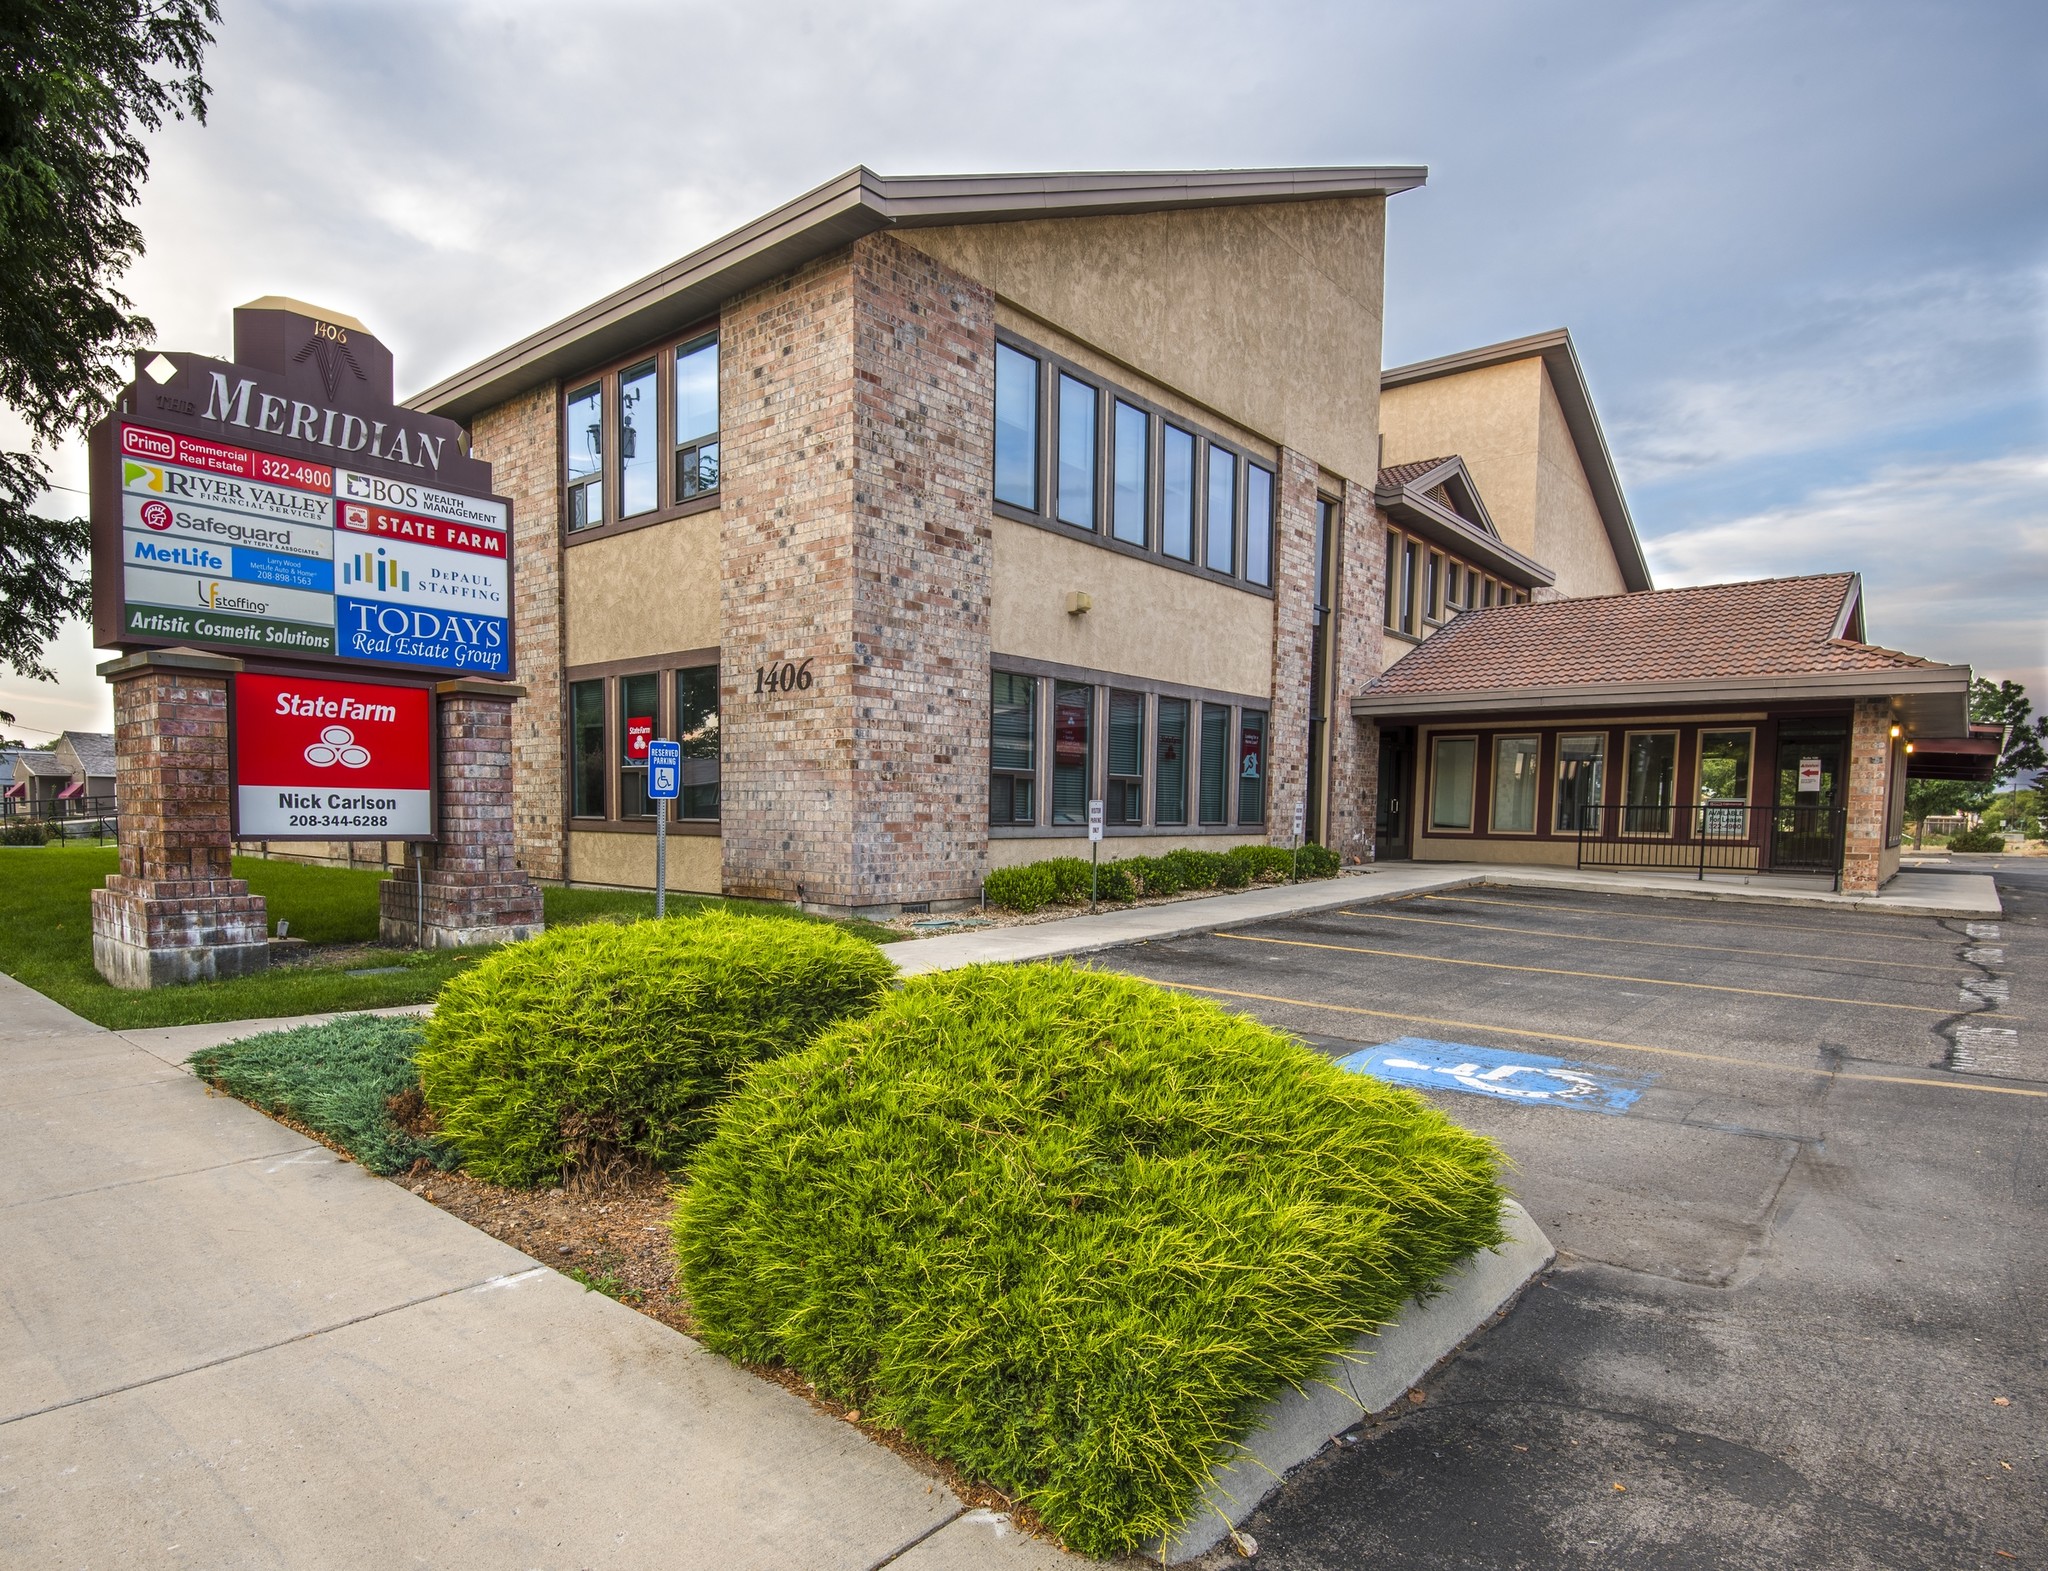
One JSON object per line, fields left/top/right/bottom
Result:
{"left": 92, "top": 649, "right": 270, "bottom": 989}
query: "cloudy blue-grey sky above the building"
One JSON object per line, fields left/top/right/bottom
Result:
{"left": 0, "top": 0, "right": 2048, "bottom": 737}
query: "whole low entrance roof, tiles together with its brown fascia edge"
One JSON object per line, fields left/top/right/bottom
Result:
{"left": 1352, "top": 574, "right": 1970, "bottom": 731}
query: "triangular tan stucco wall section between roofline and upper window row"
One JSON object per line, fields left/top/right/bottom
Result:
{"left": 899, "top": 197, "right": 1386, "bottom": 491}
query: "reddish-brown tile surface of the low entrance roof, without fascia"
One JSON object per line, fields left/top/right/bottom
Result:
{"left": 1360, "top": 574, "right": 1937, "bottom": 698}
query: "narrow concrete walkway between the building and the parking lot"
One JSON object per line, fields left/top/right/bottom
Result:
{"left": 889, "top": 862, "right": 2003, "bottom": 977}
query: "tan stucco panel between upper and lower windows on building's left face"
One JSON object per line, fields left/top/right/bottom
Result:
{"left": 561, "top": 508, "right": 719, "bottom": 666}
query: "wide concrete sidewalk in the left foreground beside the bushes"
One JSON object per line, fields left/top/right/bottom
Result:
{"left": 0, "top": 977, "right": 1083, "bottom": 1571}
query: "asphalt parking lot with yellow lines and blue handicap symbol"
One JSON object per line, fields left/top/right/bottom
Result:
{"left": 1100, "top": 871, "right": 2048, "bottom": 1571}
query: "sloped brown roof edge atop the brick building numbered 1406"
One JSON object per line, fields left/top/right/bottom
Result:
{"left": 408, "top": 166, "right": 1430, "bottom": 420}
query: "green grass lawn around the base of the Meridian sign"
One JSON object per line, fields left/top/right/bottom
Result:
{"left": 0, "top": 844, "right": 895, "bottom": 1030}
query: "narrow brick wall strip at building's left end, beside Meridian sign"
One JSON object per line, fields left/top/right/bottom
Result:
{"left": 469, "top": 383, "right": 567, "bottom": 879}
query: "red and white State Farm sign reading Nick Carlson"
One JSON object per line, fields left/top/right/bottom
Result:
{"left": 233, "top": 672, "right": 434, "bottom": 840}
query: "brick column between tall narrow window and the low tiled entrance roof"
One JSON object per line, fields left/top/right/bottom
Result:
{"left": 1327, "top": 481, "right": 1386, "bottom": 864}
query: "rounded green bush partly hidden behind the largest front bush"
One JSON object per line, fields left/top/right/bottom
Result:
{"left": 420, "top": 909, "right": 895, "bottom": 1184}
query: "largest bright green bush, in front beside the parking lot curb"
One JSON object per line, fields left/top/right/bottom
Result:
{"left": 674, "top": 965, "right": 1501, "bottom": 1555}
